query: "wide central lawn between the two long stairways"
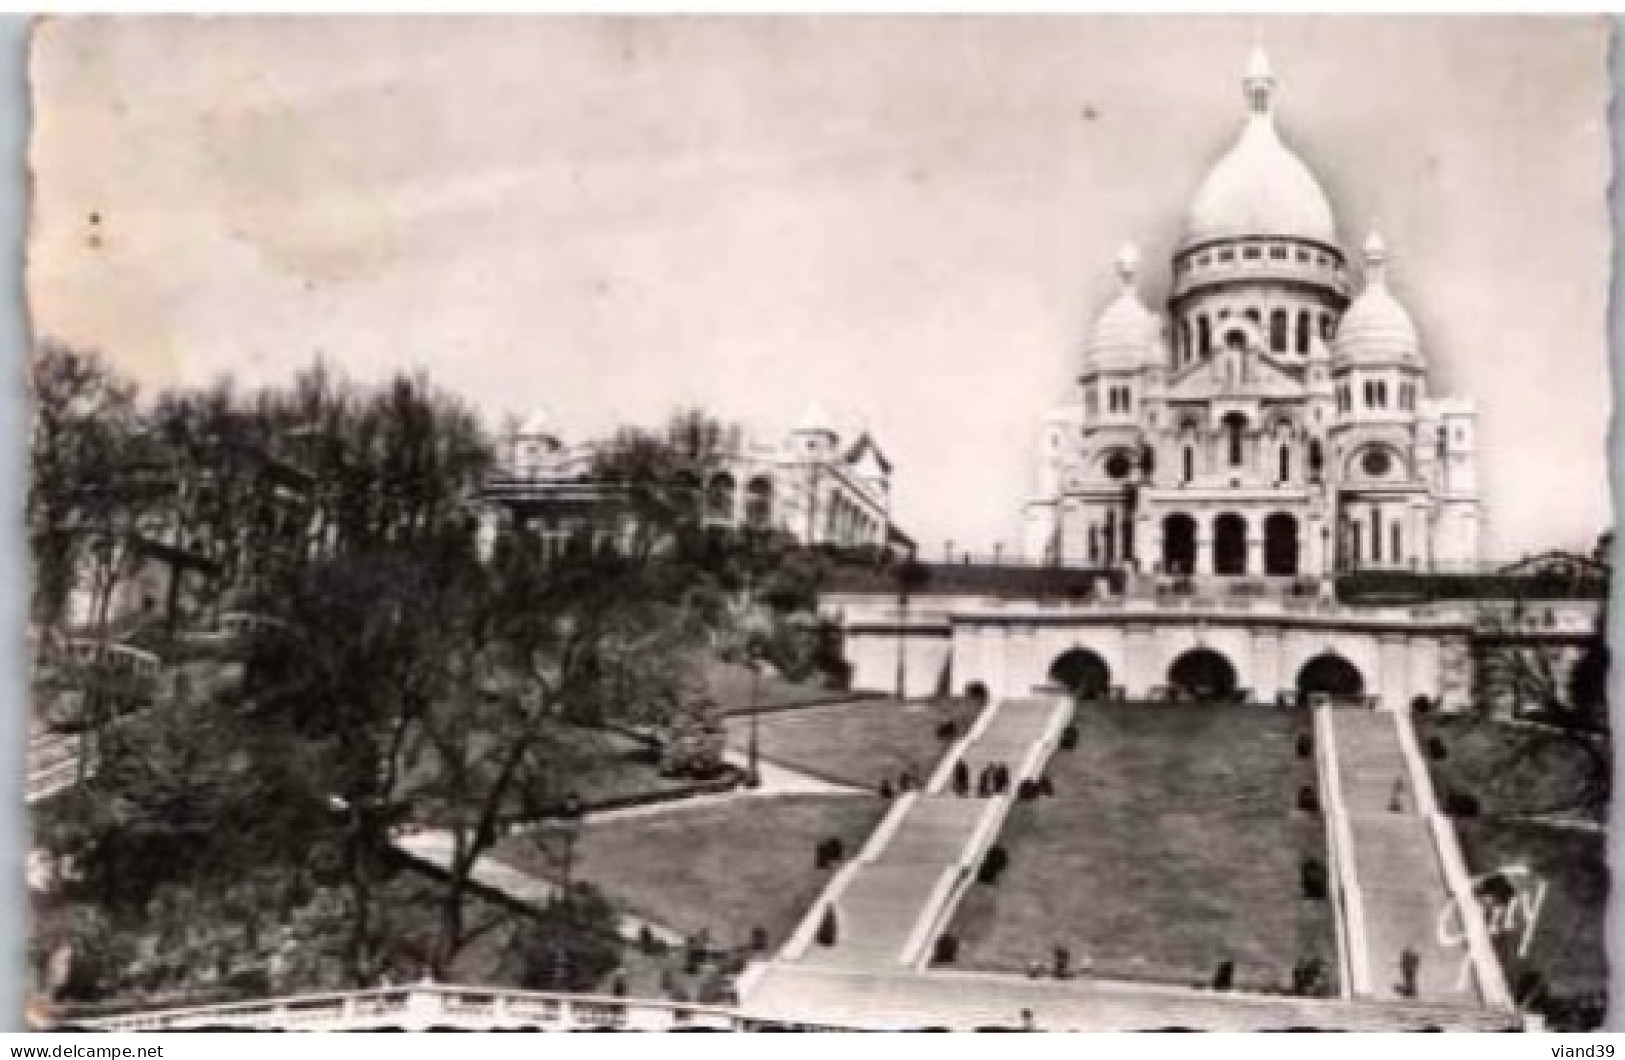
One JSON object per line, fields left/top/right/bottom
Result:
{"left": 949, "top": 704, "right": 1337, "bottom": 990}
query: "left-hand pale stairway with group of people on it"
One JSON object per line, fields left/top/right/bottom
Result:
{"left": 783, "top": 699, "right": 1071, "bottom": 971}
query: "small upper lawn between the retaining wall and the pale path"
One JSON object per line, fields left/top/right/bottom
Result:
{"left": 728, "top": 699, "right": 982, "bottom": 790}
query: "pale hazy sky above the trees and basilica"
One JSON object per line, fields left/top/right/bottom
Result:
{"left": 29, "top": 16, "right": 1610, "bottom": 556}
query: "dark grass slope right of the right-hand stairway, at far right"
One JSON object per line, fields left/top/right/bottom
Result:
{"left": 1417, "top": 717, "right": 1609, "bottom": 1031}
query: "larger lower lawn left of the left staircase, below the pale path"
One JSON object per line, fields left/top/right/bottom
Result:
{"left": 496, "top": 795, "right": 886, "bottom": 948}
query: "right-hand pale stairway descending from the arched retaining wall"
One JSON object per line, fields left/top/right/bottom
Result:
{"left": 1331, "top": 710, "right": 1480, "bottom": 1005}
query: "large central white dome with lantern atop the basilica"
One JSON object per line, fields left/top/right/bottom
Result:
{"left": 1185, "top": 50, "right": 1337, "bottom": 245}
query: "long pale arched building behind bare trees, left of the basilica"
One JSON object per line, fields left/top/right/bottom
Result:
{"left": 484, "top": 403, "right": 913, "bottom": 551}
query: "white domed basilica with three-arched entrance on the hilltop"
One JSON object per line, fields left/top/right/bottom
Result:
{"left": 1024, "top": 50, "right": 1479, "bottom": 579}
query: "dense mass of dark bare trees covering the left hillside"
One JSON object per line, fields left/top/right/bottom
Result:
{"left": 28, "top": 346, "right": 816, "bottom": 997}
